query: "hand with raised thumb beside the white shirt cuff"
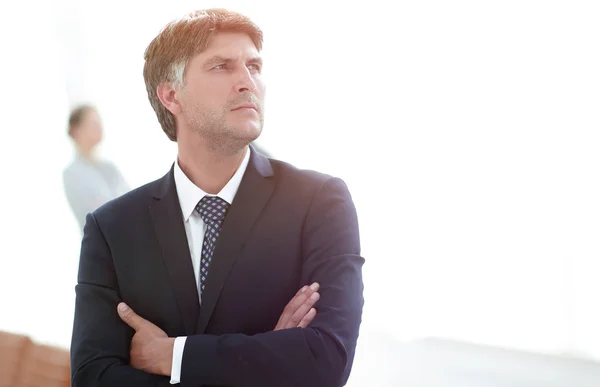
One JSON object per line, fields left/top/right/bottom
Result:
{"left": 117, "top": 302, "right": 175, "bottom": 376}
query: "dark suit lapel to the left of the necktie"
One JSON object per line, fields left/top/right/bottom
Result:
{"left": 150, "top": 168, "right": 200, "bottom": 335}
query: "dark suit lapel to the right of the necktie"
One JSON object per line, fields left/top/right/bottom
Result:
{"left": 196, "top": 149, "right": 274, "bottom": 333}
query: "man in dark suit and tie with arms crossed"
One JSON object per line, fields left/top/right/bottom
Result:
{"left": 71, "top": 6, "right": 364, "bottom": 387}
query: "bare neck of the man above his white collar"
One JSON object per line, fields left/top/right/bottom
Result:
{"left": 177, "top": 142, "right": 250, "bottom": 195}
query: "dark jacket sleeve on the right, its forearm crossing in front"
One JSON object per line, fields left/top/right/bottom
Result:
{"left": 181, "top": 178, "right": 364, "bottom": 387}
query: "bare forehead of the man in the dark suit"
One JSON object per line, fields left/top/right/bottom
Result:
{"left": 198, "top": 32, "right": 259, "bottom": 59}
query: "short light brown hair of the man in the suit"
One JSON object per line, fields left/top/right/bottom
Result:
{"left": 144, "top": 8, "right": 262, "bottom": 141}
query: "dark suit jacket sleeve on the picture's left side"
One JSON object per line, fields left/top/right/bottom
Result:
{"left": 71, "top": 214, "right": 170, "bottom": 387}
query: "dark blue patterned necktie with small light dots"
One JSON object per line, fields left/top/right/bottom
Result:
{"left": 196, "top": 196, "right": 229, "bottom": 294}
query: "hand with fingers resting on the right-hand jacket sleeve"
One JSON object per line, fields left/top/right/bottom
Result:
{"left": 273, "top": 282, "right": 321, "bottom": 331}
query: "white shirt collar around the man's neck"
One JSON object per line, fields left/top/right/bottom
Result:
{"left": 173, "top": 147, "right": 250, "bottom": 222}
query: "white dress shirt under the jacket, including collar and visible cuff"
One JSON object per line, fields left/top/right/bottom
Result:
{"left": 171, "top": 149, "right": 250, "bottom": 384}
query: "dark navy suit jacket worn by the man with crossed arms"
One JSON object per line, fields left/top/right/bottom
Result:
{"left": 71, "top": 150, "right": 364, "bottom": 387}
